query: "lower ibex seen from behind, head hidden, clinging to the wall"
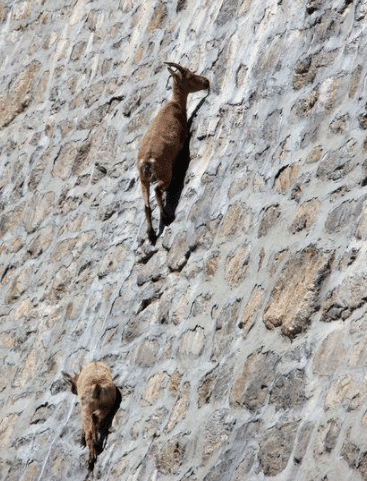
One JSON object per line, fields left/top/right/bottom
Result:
{"left": 62, "top": 362, "right": 118, "bottom": 469}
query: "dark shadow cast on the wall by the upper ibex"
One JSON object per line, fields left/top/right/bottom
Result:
{"left": 163, "top": 96, "right": 207, "bottom": 232}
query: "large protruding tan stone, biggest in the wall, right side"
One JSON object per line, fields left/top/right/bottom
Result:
{"left": 263, "top": 247, "right": 333, "bottom": 337}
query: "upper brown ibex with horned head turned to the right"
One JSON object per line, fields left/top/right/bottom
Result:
{"left": 138, "top": 62, "right": 209, "bottom": 244}
